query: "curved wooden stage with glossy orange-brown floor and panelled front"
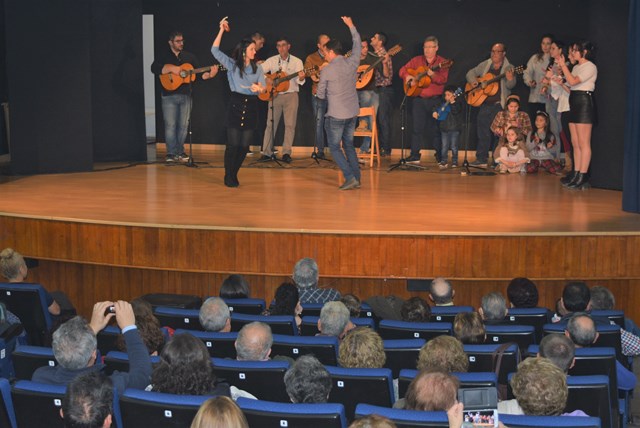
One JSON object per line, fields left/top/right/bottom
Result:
{"left": 0, "top": 146, "right": 640, "bottom": 316}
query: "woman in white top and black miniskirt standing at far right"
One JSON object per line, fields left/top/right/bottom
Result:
{"left": 558, "top": 40, "right": 598, "bottom": 189}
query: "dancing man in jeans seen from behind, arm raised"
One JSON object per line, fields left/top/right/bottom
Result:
{"left": 317, "top": 16, "right": 362, "bottom": 190}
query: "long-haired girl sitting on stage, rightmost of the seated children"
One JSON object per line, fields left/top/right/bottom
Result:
{"left": 526, "top": 111, "right": 562, "bottom": 174}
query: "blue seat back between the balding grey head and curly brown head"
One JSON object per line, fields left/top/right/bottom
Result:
{"left": 271, "top": 334, "right": 338, "bottom": 366}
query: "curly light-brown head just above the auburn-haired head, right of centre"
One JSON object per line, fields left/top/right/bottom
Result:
{"left": 418, "top": 335, "right": 469, "bottom": 373}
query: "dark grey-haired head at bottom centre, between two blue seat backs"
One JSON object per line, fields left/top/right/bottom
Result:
{"left": 284, "top": 355, "right": 331, "bottom": 403}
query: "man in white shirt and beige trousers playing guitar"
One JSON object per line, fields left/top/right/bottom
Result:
{"left": 261, "top": 37, "right": 305, "bottom": 163}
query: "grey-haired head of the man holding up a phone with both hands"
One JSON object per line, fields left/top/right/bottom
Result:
{"left": 52, "top": 316, "right": 98, "bottom": 370}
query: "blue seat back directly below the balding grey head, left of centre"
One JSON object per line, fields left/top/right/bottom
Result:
{"left": 212, "top": 358, "right": 291, "bottom": 403}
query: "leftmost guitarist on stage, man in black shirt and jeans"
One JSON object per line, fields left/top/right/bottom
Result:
{"left": 151, "top": 31, "right": 218, "bottom": 162}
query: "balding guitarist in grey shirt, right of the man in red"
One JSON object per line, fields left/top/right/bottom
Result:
{"left": 466, "top": 43, "right": 516, "bottom": 167}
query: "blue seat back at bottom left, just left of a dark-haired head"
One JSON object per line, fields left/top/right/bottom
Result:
{"left": 11, "top": 380, "right": 67, "bottom": 428}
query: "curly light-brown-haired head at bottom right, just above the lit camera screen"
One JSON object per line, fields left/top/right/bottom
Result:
{"left": 510, "top": 357, "right": 569, "bottom": 416}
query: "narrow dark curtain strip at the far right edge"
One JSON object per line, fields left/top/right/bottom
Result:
{"left": 622, "top": 0, "right": 640, "bottom": 213}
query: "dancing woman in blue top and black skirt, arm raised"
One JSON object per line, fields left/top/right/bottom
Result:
{"left": 211, "top": 18, "right": 265, "bottom": 187}
